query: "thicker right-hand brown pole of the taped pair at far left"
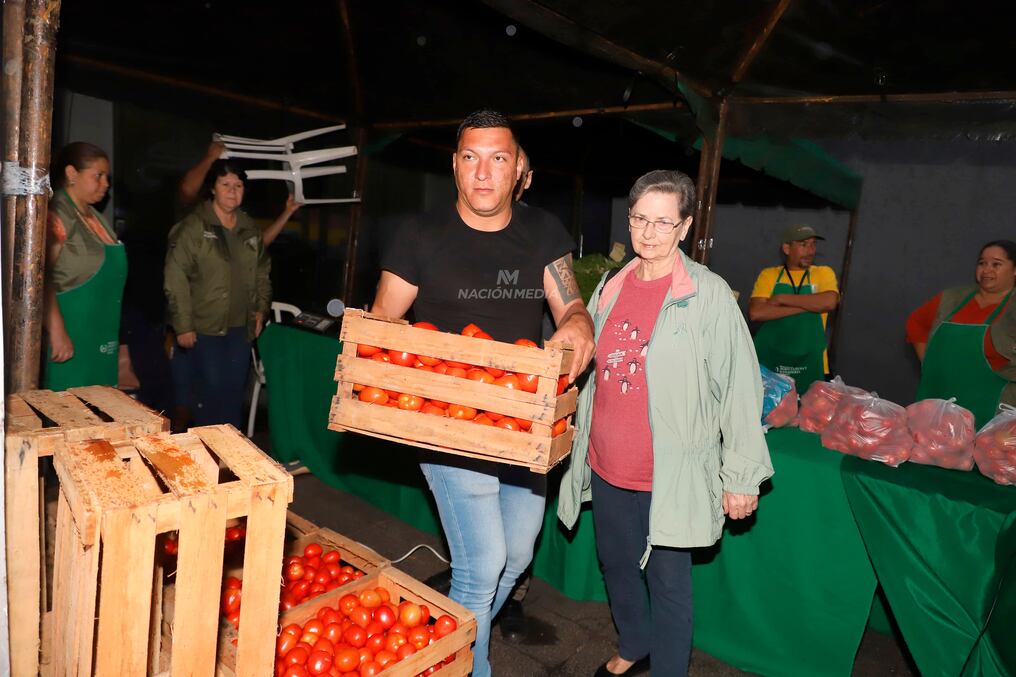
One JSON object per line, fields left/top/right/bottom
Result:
{"left": 8, "top": 0, "right": 60, "bottom": 392}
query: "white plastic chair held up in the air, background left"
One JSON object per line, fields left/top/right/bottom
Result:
{"left": 214, "top": 125, "right": 360, "bottom": 204}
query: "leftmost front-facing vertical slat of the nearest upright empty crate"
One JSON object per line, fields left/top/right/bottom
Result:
{"left": 96, "top": 505, "right": 157, "bottom": 677}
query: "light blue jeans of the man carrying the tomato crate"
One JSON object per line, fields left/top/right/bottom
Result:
{"left": 420, "top": 456, "right": 547, "bottom": 677}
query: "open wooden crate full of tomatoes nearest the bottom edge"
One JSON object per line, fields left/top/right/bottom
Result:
{"left": 219, "top": 567, "right": 477, "bottom": 677}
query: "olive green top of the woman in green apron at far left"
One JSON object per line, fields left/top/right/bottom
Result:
{"left": 47, "top": 190, "right": 117, "bottom": 294}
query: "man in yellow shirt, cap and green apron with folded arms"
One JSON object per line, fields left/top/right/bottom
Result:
{"left": 748, "top": 225, "right": 839, "bottom": 394}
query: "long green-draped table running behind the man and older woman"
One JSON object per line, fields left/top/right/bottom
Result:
{"left": 258, "top": 325, "right": 875, "bottom": 675}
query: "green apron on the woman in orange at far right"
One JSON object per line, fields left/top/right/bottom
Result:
{"left": 916, "top": 290, "right": 1012, "bottom": 428}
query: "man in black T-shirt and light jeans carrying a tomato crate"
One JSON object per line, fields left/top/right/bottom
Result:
{"left": 372, "top": 111, "right": 594, "bottom": 677}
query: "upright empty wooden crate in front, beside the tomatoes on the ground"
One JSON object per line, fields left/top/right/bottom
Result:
{"left": 50, "top": 426, "right": 293, "bottom": 676}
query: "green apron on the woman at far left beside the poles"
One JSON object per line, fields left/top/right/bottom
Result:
{"left": 43, "top": 243, "right": 127, "bottom": 390}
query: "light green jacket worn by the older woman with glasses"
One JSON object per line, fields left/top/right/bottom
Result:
{"left": 558, "top": 253, "right": 772, "bottom": 566}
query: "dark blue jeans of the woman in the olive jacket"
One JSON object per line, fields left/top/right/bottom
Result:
{"left": 174, "top": 326, "right": 251, "bottom": 430}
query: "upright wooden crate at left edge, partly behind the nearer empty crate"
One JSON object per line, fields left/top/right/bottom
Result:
{"left": 4, "top": 385, "right": 170, "bottom": 675}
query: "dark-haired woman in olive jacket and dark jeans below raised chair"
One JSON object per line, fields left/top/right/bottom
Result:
{"left": 164, "top": 160, "right": 271, "bottom": 427}
